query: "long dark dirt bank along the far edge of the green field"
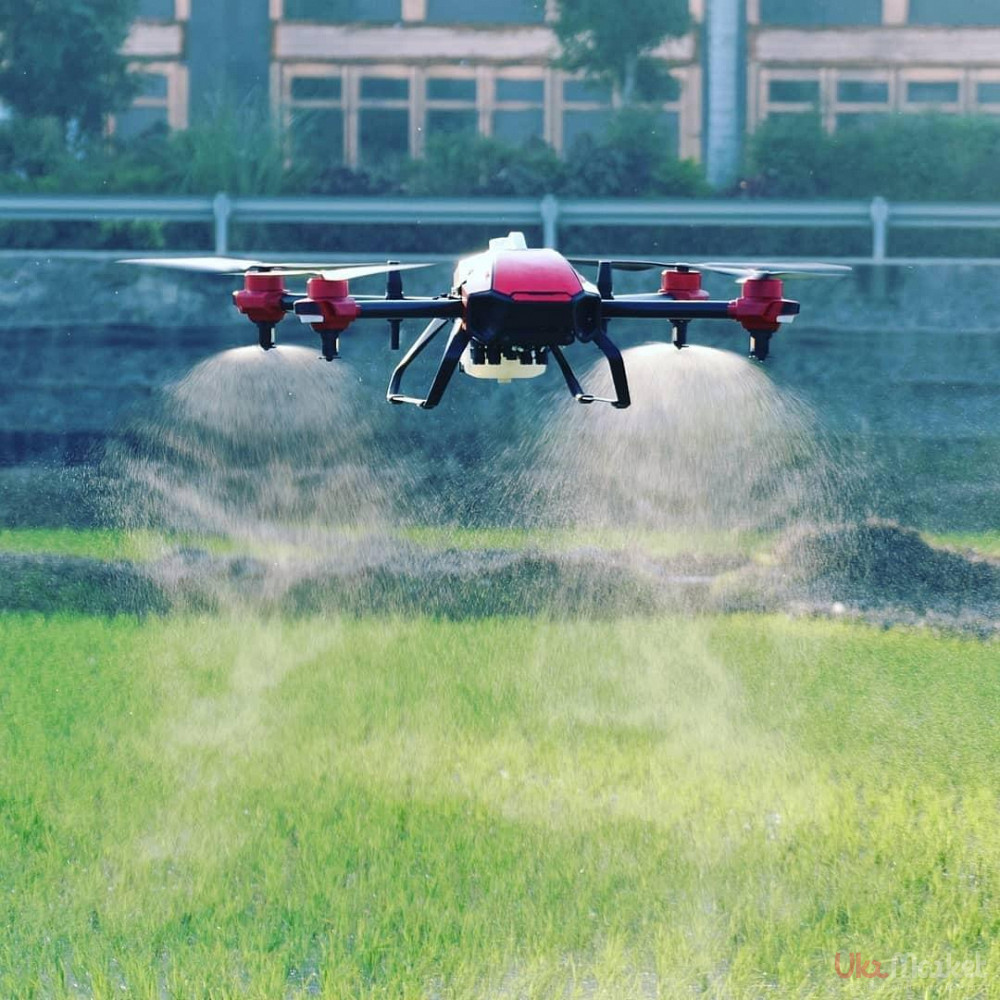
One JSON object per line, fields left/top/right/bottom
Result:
{"left": 0, "top": 522, "right": 1000, "bottom": 635}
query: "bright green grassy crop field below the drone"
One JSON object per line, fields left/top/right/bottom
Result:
{"left": 0, "top": 615, "right": 1000, "bottom": 1000}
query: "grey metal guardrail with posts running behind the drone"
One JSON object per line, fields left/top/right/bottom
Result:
{"left": 0, "top": 194, "right": 1000, "bottom": 264}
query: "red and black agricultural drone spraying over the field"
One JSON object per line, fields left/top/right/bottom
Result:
{"left": 124, "top": 233, "right": 850, "bottom": 410}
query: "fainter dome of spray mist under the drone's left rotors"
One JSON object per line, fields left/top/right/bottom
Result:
{"left": 110, "top": 346, "right": 400, "bottom": 543}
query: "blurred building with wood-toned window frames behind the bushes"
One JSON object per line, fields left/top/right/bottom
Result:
{"left": 116, "top": 0, "right": 1000, "bottom": 178}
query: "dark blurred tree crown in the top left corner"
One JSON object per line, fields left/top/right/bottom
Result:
{"left": 0, "top": 0, "right": 136, "bottom": 137}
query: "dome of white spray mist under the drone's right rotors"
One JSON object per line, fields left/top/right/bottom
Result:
{"left": 538, "top": 344, "right": 838, "bottom": 531}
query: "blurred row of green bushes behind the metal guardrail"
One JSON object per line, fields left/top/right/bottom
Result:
{"left": 0, "top": 105, "right": 1000, "bottom": 257}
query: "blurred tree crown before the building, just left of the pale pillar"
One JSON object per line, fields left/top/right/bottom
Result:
{"left": 553, "top": 0, "right": 691, "bottom": 106}
